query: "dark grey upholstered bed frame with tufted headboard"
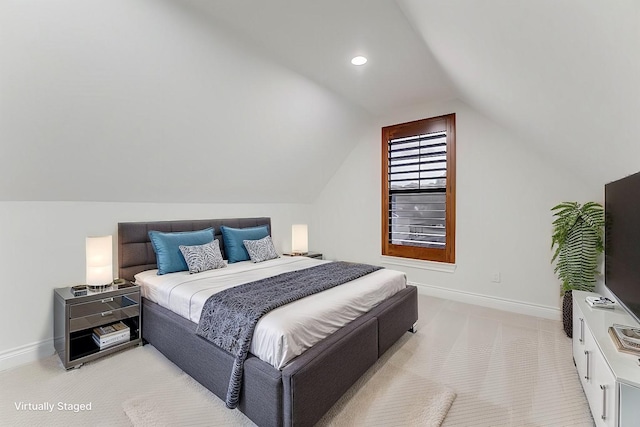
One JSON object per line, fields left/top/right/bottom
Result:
{"left": 118, "top": 218, "right": 418, "bottom": 427}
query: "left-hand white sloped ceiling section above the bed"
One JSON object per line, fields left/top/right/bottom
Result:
{"left": 0, "top": 0, "right": 378, "bottom": 203}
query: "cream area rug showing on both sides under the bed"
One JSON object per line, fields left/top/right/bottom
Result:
{"left": 123, "top": 350, "right": 456, "bottom": 427}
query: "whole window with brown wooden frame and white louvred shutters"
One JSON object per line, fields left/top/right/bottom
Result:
{"left": 382, "top": 114, "right": 456, "bottom": 263}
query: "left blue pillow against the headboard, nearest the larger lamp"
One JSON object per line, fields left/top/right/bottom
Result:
{"left": 149, "top": 227, "right": 213, "bottom": 275}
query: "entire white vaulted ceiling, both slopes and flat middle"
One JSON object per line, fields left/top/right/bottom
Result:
{"left": 0, "top": 0, "right": 640, "bottom": 202}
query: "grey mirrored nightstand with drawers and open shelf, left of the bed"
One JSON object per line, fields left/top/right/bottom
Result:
{"left": 53, "top": 282, "right": 142, "bottom": 369}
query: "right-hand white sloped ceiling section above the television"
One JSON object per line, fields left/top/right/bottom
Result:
{"left": 398, "top": 0, "right": 640, "bottom": 185}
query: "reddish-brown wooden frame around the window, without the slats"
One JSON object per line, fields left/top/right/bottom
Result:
{"left": 382, "top": 113, "right": 456, "bottom": 264}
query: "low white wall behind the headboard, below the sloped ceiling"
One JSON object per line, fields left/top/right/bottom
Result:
{"left": 0, "top": 202, "right": 313, "bottom": 370}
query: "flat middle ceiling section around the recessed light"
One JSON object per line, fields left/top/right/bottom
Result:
{"left": 182, "top": 0, "right": 455, "bottom": 115}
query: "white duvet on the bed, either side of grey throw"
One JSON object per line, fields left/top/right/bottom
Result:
{"left": 136, "top": 257, "right": 406, "bottom": 369}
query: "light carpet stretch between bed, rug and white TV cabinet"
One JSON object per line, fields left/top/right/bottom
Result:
{"left": 420, "top": 296, "right": 594, "bottom": 427}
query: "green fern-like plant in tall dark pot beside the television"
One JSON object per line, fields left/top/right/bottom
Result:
{"left": 551, "top": 202, "right": 604, "bottom": 338}
